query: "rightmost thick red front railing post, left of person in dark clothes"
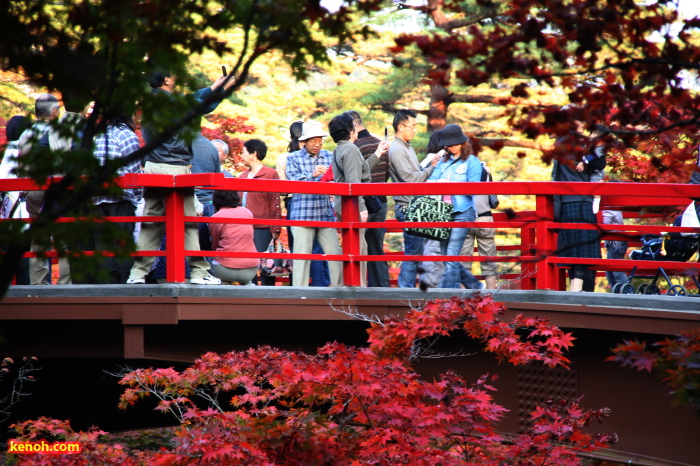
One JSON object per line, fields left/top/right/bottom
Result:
{"left": 535, "top": 195, "right": 559, "bottom": 290}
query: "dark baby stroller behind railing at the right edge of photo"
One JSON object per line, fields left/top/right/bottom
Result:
{"left": 613, "top": 226, "right": 700, "bottom": 296}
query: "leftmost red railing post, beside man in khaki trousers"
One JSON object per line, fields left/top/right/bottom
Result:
{"left": 165, "top": 189, "right": 186, "bottom": 283}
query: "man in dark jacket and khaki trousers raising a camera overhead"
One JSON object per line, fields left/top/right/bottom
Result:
{"left": 127, "top": 71, "right": 234, "bottom": 285}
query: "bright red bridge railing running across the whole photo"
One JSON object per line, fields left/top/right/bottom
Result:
{"left": 0, "top": 174, "right": 700, "bottom": 290}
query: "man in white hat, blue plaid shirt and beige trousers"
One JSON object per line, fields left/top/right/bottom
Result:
{"left": 286, "top": 121, "right": 343, "bottom": 287}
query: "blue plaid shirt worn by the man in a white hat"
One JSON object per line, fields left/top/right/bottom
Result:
{"left": 287, "top": 148, "right": 335, "bottom": 222}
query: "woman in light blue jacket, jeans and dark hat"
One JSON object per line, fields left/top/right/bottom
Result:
{"left": 428, "top": 125, "right": 483, "bottom": 290}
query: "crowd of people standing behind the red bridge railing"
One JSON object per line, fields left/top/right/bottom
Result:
{"left": 0, "top": 71, "right": 684, "bottom": 291}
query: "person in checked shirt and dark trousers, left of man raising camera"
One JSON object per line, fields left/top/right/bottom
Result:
{"left": 86, "top": 116, "right": 141, "bottom": 283}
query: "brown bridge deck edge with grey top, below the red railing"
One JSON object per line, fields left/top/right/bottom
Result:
{"left": 0, "top": 283, "right": 700, "bottom": 360}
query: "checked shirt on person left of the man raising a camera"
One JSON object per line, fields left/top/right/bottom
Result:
{"left": 92, "top": 125, "right": 141, "bottom": 206}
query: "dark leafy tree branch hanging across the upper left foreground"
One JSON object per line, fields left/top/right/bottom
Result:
{"left": 0, "top": 0, "right": 381, "bottom": 296}
